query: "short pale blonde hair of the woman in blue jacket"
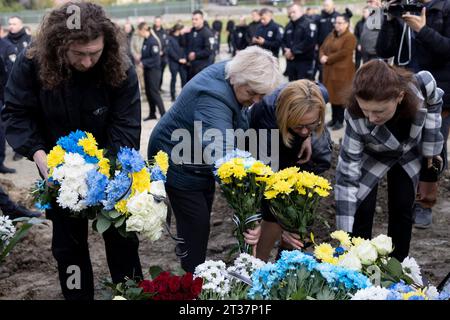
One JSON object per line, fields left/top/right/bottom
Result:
{"left": 225, "top": 46, "right": 283, "bottom": 95}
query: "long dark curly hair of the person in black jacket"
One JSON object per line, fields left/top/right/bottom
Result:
{"left": 27, "top": 1, "right": 129, "bottom": 89}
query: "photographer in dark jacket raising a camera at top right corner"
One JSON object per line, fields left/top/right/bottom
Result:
{"left": 377, "top": 0, "right": 450, "bottom": 228}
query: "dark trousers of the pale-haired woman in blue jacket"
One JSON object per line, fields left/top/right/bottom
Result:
{"left": 166, "top": 181, "right": 215, "bottom": 272}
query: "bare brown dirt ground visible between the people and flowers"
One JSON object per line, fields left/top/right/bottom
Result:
{"left": 0, "top": 49, "right": 450, "bottom": 300}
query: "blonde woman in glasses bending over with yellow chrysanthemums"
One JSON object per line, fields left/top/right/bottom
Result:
{"left": 245, "top": 80, "right": 332, "bottom": 261}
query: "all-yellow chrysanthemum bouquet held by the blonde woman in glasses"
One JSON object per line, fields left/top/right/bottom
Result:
{"left": 264, "top": 167, "right": 331, "bottom": 246}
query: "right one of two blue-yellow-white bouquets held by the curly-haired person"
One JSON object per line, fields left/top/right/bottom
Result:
{"left": 95, "top": 147, "right": 169, "bottom": 241}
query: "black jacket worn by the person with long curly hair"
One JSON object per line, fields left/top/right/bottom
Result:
{"left": 2, "top": 53, "right": 141, "bottom": 160}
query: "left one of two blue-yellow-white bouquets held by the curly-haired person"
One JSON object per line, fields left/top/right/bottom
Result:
{"left": 32, "top": 130, "right": 110, "bottom": 218}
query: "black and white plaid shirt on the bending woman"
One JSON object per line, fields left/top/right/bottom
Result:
{"left": 335, "top": 71, "right": 443, "bottom": 232}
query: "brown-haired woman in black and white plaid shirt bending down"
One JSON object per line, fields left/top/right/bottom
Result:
{"left": 335, "top": 60, "right": 443, "bottom": 261}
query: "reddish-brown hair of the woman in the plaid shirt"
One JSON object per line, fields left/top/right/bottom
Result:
{"left": 347, "top": 60, "right": 420, "bottom": 119}
